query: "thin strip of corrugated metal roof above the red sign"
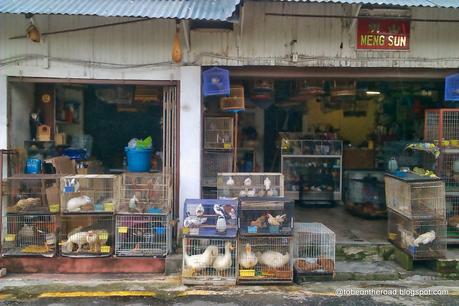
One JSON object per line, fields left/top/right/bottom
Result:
{"left": 279, "top": 0, "right": 459, "bottom": 8}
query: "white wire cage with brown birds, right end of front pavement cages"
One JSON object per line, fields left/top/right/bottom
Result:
{"left": 293, "top": 223, "right": 336, "bottom": 274}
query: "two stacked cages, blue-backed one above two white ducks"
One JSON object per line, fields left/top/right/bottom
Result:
{"left": 182, "top": 199, "right": 239, "bottom": 285}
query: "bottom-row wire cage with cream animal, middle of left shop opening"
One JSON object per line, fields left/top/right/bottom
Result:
{"left": 59, "top": 214, "right": 114, "bottom": 257}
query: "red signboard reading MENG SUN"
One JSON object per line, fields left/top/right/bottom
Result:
{"left": 357, "top": 18, "right": 410, "bottom": 50}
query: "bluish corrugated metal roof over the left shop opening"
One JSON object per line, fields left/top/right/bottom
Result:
{"left": 0, "top": 0, "right": 240, "bottom": 20}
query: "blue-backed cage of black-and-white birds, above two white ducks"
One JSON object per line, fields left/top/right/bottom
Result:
{"left": 182, "top": 199, "right": 239, "bottom": 238}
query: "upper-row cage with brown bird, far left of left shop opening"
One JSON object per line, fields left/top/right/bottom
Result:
{"left": 1, "top": 174, "right": 60, "bottom": 214}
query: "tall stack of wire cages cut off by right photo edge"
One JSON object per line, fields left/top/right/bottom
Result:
{"left": 424, "top": 108, "right": 459, "bottom": 244}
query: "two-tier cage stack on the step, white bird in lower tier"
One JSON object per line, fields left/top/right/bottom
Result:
{"left": 385, "top": 174, "right": 446, "bottom": 260}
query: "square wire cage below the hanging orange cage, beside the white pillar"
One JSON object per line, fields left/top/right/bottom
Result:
{"left": 204, "top": 117, "right": 234, "bottom": 150}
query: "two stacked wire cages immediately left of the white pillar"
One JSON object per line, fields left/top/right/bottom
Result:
{"left": 115, "top": 172, "right": 172, "bottom": 257}
